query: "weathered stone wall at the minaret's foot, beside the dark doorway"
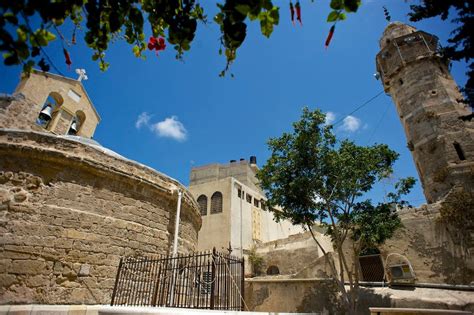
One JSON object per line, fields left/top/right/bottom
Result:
{"left": 336, "top": 203, "right": 474, "bottom": 285}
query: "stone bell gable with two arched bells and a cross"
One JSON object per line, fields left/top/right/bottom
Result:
{"left": 0, "top": 69, "right": 100, "bottom": 138}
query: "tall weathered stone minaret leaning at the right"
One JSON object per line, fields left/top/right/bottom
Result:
{"left": 376, "top": 22, "right": 474, "bottom": 203}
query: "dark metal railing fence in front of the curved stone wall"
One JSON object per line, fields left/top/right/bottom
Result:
{"left": 111, "top": 249, "right": 244, "bottom": 310}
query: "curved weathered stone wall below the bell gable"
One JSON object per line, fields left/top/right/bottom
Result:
{"left": 0, "top": 129, "right": 201, "bottom": 304}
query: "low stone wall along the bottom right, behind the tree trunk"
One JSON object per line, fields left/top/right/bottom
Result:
{"left": 245, "top": 279, "right": 474, "bottom": 314}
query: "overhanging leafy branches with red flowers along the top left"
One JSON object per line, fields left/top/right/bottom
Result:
{"left": 0, "top": 0, "right": 361, "bottom": 74}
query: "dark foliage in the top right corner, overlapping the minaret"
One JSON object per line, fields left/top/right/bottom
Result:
{"left": 409, "top": 0, "right": 474, "bottom": 108}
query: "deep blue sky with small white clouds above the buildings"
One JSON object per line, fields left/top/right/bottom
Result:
{"left": 0, "top": 0, "right": 466, "bottom": 205}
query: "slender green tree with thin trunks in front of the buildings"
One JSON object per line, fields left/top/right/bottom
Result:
{"left": 257, "top": 108, "right": 415, "bottom": 314}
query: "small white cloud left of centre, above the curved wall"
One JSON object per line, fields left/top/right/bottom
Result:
{"left": 135, "top": 112, "right": 188, "bottom": 142}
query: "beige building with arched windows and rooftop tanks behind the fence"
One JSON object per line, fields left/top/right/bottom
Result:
{"left": 189, "top": 157, "right": 302, "bottom": 255}
